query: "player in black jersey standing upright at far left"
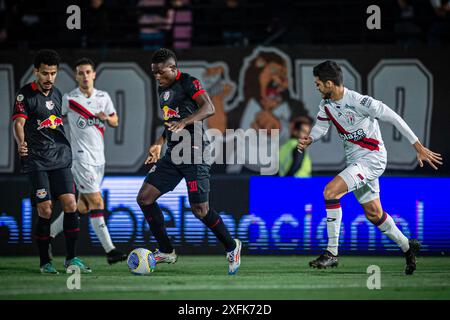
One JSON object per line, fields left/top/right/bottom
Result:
{"left": 12, "top": 50, "right": 91, "bottom": 274}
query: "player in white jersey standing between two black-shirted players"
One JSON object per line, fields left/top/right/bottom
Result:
{"left": 50, "top": 58, "right": 127, "bottom": 264}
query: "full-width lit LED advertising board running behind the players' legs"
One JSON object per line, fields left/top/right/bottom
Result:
{"left": 0, "top": 176, "right": 450, "bottom": 254}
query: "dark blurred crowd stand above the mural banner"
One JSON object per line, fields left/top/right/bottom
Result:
{"left": 0, "top": 0, "right": 450, "bottom": 50}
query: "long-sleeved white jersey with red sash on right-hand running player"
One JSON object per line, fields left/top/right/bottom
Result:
{"left": 310, "top": 88, "right": 417, "bottom": 163}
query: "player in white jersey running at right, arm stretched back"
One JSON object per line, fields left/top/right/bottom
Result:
{"left": 297, "top": 61, "right": 442, "bottom": 274}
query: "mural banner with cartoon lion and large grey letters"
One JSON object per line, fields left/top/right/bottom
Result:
{"left": 0, "top": 47, "right": 450, "bottom": 175}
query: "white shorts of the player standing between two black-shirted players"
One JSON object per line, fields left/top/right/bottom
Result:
{"left": 72, "top": 160, "right": 105, "bottom": 193}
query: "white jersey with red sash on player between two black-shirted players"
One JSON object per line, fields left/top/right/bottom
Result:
{"left": 62, "top": 88, "right": 116, "bottom": 166}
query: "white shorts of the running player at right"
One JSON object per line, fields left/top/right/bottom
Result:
{"left": 339, "top": 158, "right": 386, "bottom": 204}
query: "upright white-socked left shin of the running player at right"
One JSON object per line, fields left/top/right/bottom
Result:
{"left": 325, "top": 199, "right": 342, "bottom": 256}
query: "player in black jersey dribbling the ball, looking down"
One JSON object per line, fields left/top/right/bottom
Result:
{"left": 137, "top": 48, "right": 242, "bottom": 275}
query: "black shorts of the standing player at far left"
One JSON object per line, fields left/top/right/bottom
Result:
{"left": 28, "top": 168, "right": 75, "bottom": 205}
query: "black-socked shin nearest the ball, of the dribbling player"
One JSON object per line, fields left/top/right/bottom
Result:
{"left": 139, "top": 202, "right": 173, "bottom": 253}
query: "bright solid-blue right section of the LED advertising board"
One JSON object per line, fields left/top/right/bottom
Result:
{"left": 249, "top": 177, "right": 450, "bottom": 254}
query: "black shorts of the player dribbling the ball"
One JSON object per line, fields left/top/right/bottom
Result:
{"left": 144, "top": 155, "right": 211, "bottom": 203}
